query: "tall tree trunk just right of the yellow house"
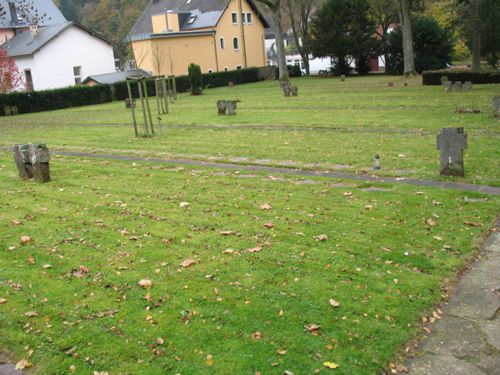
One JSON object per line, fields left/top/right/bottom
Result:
{"left": 286, "top": 0, "right": 319, "bottom": 75}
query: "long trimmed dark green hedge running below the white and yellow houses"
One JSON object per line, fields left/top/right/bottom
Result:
{"left": 0, "top": 67, "right": 269, "bottom": 116}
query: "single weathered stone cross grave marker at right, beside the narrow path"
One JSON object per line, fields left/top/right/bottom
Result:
{"left": 437, "top": 128, "right": 467, "bottom": 177}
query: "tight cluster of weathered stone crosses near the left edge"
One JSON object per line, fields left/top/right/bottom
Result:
{"left": 13, "top": 143, "right": 50, "bottom": 182}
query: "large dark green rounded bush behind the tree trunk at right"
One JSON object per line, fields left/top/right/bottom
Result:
{"left": 386, "top": 16, "right": 453, "bottom": 74}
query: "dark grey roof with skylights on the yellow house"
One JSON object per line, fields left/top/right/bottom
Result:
{"left": 129, "top": 0, "right": 269, "bottom": 39}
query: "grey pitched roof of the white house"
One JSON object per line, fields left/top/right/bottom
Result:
{"left": 0, "top": 22, "right": 111, "bottom": 57}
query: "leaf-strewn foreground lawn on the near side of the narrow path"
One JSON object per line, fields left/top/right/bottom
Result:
{"left": 0, "top": 154, "right": 500, "bottom": 375}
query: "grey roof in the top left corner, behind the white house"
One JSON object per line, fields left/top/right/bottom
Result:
{"left": 0, "top": 0, "right": 67, "bottom": 29}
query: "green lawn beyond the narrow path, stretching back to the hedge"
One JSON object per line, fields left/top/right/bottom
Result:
{"left": 0, "top": 76, "right": 500, "bottom": 186}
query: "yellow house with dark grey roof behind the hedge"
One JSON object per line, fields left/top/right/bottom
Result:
{"left": 128, "top": 0, "right": 269, "bottom": 75}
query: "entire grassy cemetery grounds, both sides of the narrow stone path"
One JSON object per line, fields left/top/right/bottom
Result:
{"left": 0, "top": 76, "right": 500, "bottom": 375}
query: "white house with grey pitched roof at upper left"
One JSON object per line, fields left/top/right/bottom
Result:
{"left": 1, "top": 0, "right": 115, "bottom": 90}
